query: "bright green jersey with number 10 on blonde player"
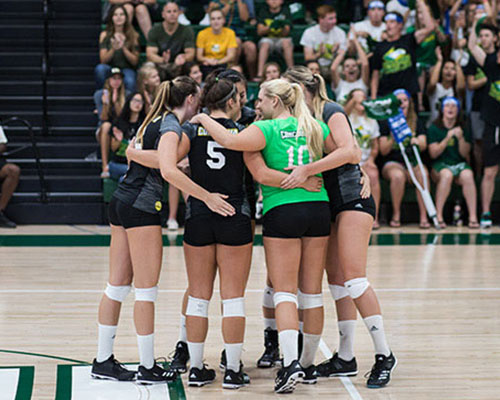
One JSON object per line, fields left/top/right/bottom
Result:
{"left": 252, "top": 117, "right": 330, "bottom": 214}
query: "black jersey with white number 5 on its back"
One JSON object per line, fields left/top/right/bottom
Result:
{"left": 182, "top": 118, "right": 250, "bottom": 219}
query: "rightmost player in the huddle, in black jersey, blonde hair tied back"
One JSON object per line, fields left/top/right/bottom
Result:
{"left": 282, "top": 67, "right": 396, "bottom": 388}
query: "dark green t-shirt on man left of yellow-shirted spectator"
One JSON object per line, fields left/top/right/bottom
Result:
{"left": 147, "top": 22, "right": 195, "bottom": 62}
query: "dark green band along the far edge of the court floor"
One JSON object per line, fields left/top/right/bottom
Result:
{"left": 0, "top": 232, "right": 500, "bottom": 247}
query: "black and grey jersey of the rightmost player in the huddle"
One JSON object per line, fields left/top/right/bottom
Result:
{"left": 322, "top": 102, "right": 362, "bottom": 209}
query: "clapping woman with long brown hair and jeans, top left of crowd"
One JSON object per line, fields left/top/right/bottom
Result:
{"left": 95, "top": 5, "right": 139, "bottom": 91}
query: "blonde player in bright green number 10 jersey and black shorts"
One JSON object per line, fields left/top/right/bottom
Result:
{"left": 192, "top": 79, "right": 336, "bottom": 393}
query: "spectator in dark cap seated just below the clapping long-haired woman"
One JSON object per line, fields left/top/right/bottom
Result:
{"left": 94, "top": 68, "right": 126, "bottom": 178}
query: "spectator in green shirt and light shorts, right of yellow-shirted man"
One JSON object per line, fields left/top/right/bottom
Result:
{"left": 255, "top": 0, "right": 293, "bottom": 81}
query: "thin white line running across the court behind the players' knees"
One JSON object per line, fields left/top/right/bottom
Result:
{"left": 0, "top": 287, "right": 500, "bottom": 294}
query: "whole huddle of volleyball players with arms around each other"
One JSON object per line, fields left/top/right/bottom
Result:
{"left": 91, "top": 66, "right": 396, "bottom": 393}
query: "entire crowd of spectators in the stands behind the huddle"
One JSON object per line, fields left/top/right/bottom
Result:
{"left": 94, "top": 0, "right": 500, "bottom": 229}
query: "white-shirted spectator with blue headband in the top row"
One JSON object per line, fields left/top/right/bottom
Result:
{"left": 354, "top": 0, "right": 385, "bottom": 54}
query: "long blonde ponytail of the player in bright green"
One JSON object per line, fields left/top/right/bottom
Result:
{"left": 290, "top": 83, "right": 323, "bottom": 158}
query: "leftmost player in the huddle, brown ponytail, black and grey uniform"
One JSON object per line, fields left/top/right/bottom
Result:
{"left": 91, "top": 77, "right": 199, "bottom": 384}
